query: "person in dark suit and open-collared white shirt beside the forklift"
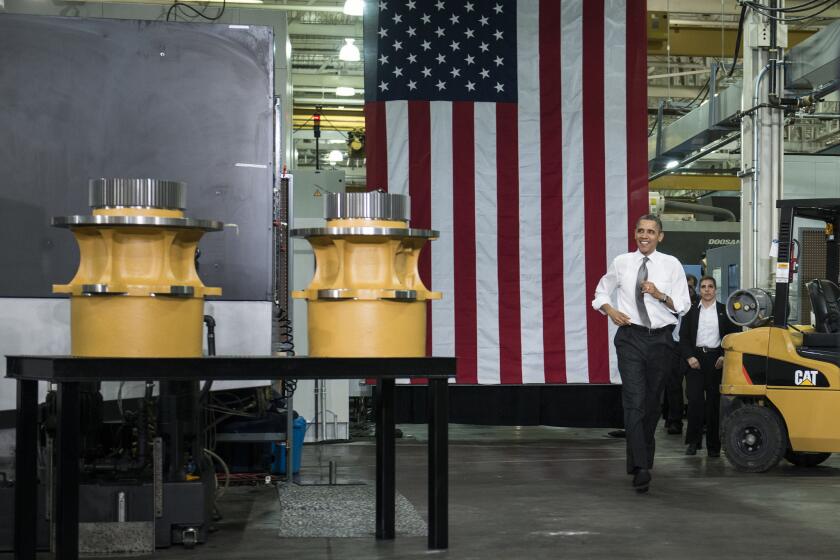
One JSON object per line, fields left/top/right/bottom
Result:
{"left": 680, "top": 276, "right": 738, "bottom": 457}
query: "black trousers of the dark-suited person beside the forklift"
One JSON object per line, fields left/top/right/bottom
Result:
{"left": 685, "top": 349, "right": 723, "bottom": 452}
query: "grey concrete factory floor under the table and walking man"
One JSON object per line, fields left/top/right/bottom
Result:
{"left": 9, "top": 425, "right": 840, "bottom": 560}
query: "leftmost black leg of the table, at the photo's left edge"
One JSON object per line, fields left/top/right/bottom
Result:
{"left": 14, "top": 380, "right": 38, "bottom": 560}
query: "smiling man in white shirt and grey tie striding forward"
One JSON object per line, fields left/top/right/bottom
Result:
{"left": 592, "top": 214, "right": 691, "bottom": 492}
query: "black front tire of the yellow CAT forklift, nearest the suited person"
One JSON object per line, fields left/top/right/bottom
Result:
{"left": 722, "top": 405, "right": 787, "bottom": 473}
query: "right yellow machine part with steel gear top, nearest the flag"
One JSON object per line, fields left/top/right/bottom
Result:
{"left": 292, "top": 192, "right": 441, "bottom": 357}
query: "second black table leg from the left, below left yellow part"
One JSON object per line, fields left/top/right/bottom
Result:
{"left": 55, "top": 382, "right": 80, "bottom": 560}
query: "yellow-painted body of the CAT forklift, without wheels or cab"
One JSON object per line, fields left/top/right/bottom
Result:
{"left": 721, "top": 327, "right": 840, "bottom": 452}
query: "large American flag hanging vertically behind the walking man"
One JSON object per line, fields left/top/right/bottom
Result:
{"left": 364, "top": 0, "right": 647, "bottom": 384}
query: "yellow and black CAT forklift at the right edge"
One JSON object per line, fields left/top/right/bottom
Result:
{"left": 721, "top": 199, "right": 840, "bottom": 472}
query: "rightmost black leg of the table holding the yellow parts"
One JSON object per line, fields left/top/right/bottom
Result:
{"left": 428, "top": 378, "right": 449, "bottom": 549}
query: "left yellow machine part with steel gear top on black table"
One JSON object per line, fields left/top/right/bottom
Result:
{"left": 53, "top": 179, "right": 223, "bottom": 357}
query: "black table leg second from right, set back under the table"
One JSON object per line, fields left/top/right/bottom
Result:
{"left": 376, "top": 379, "right": 396, "bottom": 539}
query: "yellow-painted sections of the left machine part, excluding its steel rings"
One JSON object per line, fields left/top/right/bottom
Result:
{"left": 53, "top": 208, "right": 221, "bottom": 357}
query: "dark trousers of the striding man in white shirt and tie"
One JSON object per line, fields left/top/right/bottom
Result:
{"left": 615, "top": 326, "right": 674, "bottom": 473}
